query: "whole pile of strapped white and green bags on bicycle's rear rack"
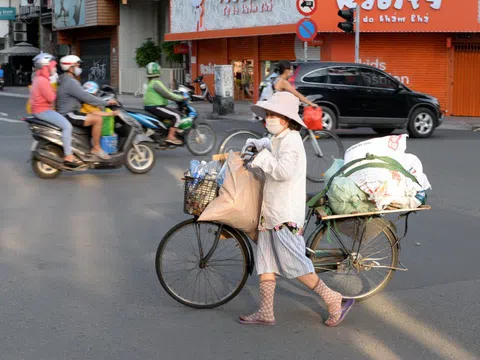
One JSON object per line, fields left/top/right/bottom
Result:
{"left": 323, "top": 135, "right": 431, "bottom": 214}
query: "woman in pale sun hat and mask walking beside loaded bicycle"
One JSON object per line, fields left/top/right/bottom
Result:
{"left": 239, "top": 91, "right": 355, "bottom": 326}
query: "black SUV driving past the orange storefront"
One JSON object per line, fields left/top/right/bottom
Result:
{"left": 289, "top": 61, "right": 443, "bottom": 138}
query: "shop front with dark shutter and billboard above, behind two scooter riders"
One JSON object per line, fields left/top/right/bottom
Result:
{"left": 53, "top": 0, "right": 120, "bottom": 88}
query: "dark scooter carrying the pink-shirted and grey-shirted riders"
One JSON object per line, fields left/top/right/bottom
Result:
{"left": 24, "top": 109, "right": 156, "bottom": 179}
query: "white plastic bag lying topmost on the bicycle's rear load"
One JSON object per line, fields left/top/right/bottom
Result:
{"left": 344, "top": 134, "right": 408, "bottom": 164}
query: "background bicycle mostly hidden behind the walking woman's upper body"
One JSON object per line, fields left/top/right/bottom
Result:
{"left": 218, "top": 120, "right": 345, "bottom": 183}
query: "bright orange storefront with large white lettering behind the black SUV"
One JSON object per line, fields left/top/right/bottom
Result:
{"left": 166, "top": 0, "right": 480, "bottom": 116}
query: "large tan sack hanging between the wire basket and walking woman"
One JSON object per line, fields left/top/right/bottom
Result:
{"left": 198, "top": 153, "right": 263, "bottom": 240}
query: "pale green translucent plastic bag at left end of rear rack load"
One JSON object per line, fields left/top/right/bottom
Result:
{"left": 327, "top": 176, "right": 375, "bottom": 215}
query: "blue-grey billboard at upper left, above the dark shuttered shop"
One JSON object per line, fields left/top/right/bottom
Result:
{"left": 52, "top": 0, "right": 86, "bottom": 29}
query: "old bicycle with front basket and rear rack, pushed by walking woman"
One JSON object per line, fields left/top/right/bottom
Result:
{"left": 155, "top": 158, "right": 431, "bottom": 309}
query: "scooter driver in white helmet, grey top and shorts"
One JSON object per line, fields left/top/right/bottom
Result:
{"left": 57, "top": 55, "right": 118, "bottom": 160}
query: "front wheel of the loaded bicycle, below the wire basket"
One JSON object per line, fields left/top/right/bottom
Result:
{"left": 155, "top": 219, "right": 249, "bottom": 309}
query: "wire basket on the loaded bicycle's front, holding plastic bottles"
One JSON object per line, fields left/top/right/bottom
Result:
{"left": 183, "top": 176, "right": 219, "bottom": 216}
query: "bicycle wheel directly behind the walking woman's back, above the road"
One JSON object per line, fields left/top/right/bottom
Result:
{"left": 303, "top": 130, "right": 345, "bottom": 183}
